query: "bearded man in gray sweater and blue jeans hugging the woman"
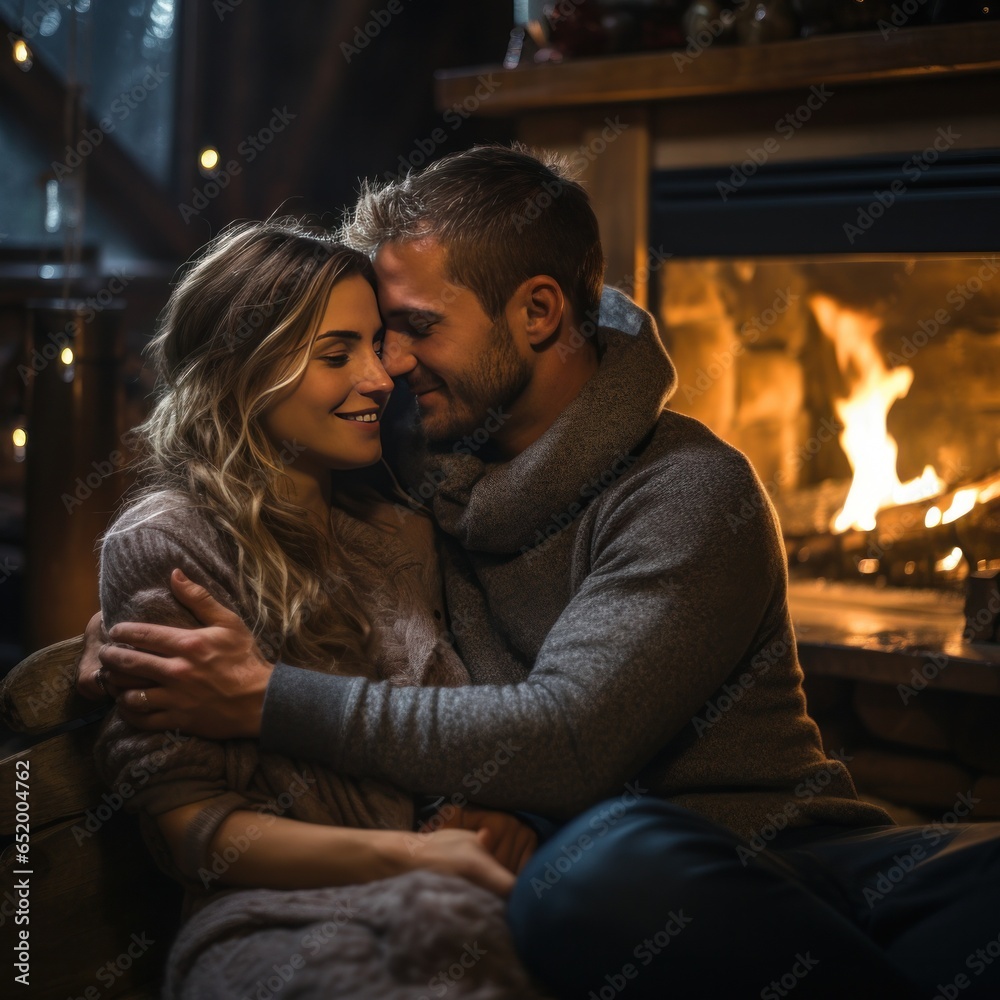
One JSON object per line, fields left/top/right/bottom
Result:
{"left": 80, "top": 148, "right": 1000, "bottom": 998}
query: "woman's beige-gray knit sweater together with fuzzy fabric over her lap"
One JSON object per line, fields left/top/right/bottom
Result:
{"left": 97, "top": 493, "right": 544, "bottom": 1000}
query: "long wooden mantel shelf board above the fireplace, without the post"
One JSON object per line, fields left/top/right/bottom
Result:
{"left": 436, "top": 22, "right": 1000, "bottom": 115}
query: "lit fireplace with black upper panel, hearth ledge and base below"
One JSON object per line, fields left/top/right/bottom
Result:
{"left": 650, "top": 151, "right": 1000, "bottom": 819}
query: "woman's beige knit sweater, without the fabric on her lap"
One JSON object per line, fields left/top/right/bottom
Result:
{"left": 96, "top": 492, "right": 468, "bottom": 892}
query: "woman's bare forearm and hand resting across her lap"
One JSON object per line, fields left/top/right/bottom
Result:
{"left": 156, "top": 802, "right": 514, "bottom": 896}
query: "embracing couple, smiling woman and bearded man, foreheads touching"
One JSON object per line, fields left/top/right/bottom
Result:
{"left": 80, "top": 148, "right": 997, "bottom": 1000}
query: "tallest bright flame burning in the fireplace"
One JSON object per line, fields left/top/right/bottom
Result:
{"left": 809, "top": 295, "right": 946, "bottom": 533}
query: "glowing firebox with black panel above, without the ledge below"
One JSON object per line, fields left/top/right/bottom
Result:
{"left": 650, "top": 145, "right": 1000, "bottom": 608}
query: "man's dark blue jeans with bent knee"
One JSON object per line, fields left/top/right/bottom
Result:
{"left": 509, "top": 798, "right": 1000, "bottom": 1000}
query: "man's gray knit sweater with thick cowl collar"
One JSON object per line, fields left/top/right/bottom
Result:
{"left": 261, "top": 290, "right": 891, "bottom": 837}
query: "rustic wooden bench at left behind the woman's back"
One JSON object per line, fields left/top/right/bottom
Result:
{"left": 0, "top": 636, "right": 181, "bottom": 1000}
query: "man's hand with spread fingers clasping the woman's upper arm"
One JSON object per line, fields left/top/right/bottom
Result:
{"left": 100, "top": 569, "right": 273, "bottom": 739}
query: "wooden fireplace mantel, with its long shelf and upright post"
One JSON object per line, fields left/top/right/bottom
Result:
{"left": 436, "top": 22, "right": 1000, "bottom": 305}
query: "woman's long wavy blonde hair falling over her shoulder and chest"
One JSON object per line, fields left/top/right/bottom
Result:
{"left": 132, "top": 219, "right": 389, "bottom": 670}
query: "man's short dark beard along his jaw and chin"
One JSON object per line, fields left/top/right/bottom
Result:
{"left": 421, "top": 316, "right": 531, "bottom": 450}
